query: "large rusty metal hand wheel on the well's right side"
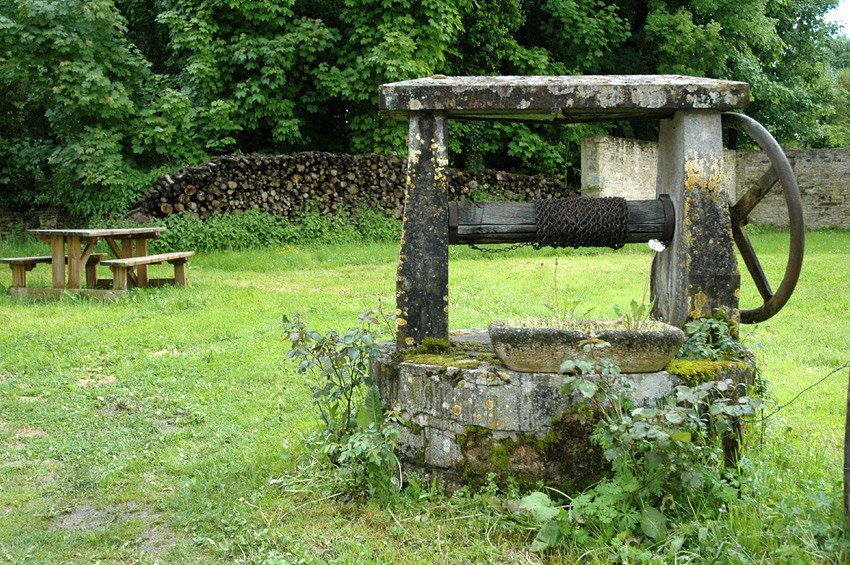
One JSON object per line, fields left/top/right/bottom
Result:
{"left": 722, "top": 113, "right": 806, "bottom": 324}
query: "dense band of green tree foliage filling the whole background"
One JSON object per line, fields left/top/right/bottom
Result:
{"left": 0, "top": 0, "right": 850, "bottom": 220}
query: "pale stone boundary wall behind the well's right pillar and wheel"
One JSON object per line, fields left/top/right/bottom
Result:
{"left": 581, "top": 136, "right": 850, "bottom": 228}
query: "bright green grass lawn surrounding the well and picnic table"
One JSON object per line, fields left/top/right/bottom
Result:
{"left": 0, "top": 231, "right": 850, "bottom": 563}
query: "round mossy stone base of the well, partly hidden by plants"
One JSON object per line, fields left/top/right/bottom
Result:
{"left": 371, "top": 330, "right": 752, "bottom": 489}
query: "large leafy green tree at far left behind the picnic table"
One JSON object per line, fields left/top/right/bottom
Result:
{"left": 0, "top": 0, "right": 198, "bottom": 217}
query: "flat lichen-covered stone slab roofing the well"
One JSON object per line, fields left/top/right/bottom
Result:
{"left": 379, "top": 75, "right": 750, "bottom": 122}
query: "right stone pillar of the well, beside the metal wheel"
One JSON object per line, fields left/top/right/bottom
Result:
{"left": 652, "top": 110, "right": 741, "bottom": 327}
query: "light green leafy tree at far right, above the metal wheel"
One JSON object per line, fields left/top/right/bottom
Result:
{"left": 605, "top": 0, "right": 837, "bottom": 145}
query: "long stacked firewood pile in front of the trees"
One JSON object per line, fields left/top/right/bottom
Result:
{"left": 127, "top": 152, "right": 573, "bottom": 221}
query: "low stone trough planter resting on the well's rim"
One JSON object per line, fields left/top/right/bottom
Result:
{"left": 488, "top": 321, "right": 685, "bottom": 373}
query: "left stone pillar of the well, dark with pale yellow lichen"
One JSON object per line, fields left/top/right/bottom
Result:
{"left": 396, "top": 112, "right": 449, "bottom": 350}
